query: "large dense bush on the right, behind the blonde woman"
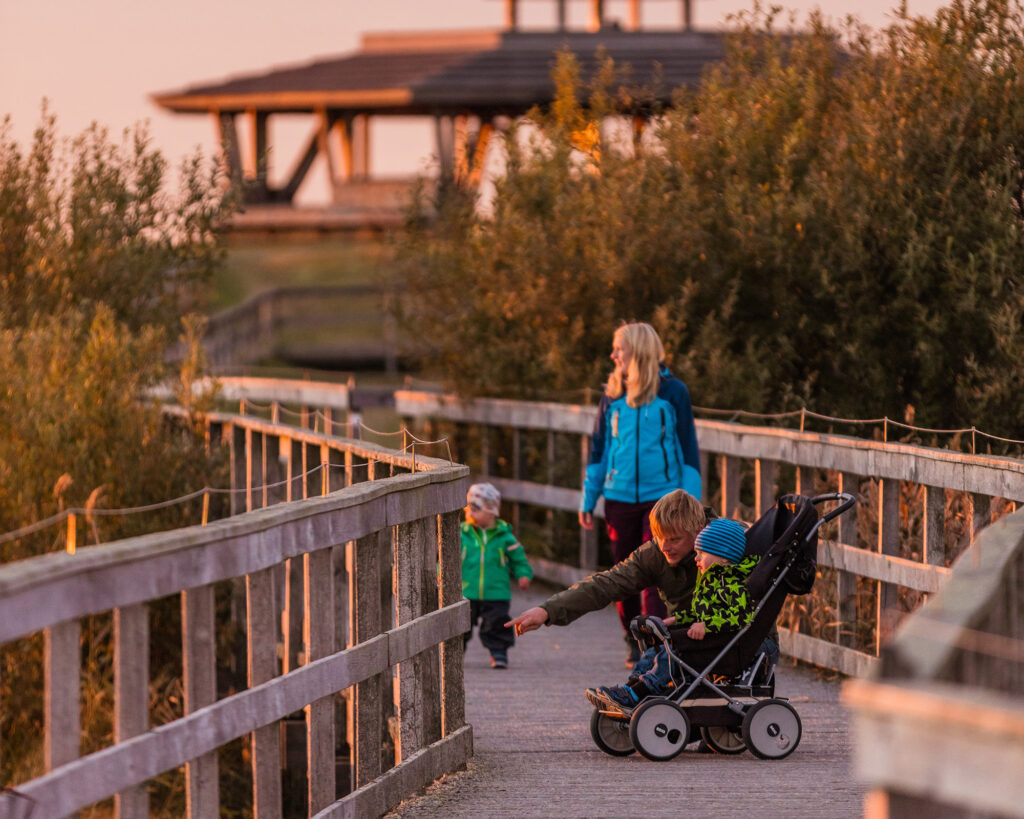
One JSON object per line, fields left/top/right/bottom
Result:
{"left": 402, "top": 0, "right": 1024, "bottom": 437}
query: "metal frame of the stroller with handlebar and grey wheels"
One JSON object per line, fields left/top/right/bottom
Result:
{"left": 591, "top": 492, "right": 856, "bottom": 762}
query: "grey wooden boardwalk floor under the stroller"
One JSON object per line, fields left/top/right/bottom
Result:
{"left": 389, "top": 587, "right": 864, "bottom": 819}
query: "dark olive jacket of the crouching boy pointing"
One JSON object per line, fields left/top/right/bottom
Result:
{"left": 541, "top": 541, "right": 697, "bottom": 626}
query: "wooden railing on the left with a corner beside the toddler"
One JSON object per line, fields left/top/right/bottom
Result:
{"left": 0, "top": 409, "right": 472, "bottom": 819}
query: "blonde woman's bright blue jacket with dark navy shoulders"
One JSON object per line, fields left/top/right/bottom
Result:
{"left": 580, "top": 368, "right": 700, "bottom": 512}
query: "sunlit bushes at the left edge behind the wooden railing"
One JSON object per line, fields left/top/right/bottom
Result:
{"left": 0, "top": 109, "right": 230, "bottom": 560}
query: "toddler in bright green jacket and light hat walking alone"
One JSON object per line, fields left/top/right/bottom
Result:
{"left": 462, "top": 483, "right": 534, "bottom": 669}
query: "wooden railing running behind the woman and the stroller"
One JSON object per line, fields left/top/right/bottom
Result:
{"left": 395, "top": 391, "right": 1024, "bottom": 676}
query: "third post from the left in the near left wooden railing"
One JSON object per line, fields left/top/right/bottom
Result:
{"left": 181, "top": 586, "right": 220, "bottom": 819}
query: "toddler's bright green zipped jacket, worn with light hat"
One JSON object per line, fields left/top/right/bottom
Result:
{"left": 462, "top": 520, "right": 534, "bottom": 600}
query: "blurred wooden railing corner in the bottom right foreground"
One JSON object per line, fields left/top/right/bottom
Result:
{"left": 844, "top": 512, "right": 1024, "bottom": 817}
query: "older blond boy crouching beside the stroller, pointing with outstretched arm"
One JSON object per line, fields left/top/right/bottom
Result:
{"left": 506, "top": 489, "right": 707, "bottom": 635}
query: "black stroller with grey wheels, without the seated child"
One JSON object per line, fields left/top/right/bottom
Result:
{"left": 590, "top": 492, "right": 855, "bottom": 762}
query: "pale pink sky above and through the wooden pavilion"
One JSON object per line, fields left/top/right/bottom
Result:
{"left": 0, "top": 0, "right": 943, "bottom": 203}
